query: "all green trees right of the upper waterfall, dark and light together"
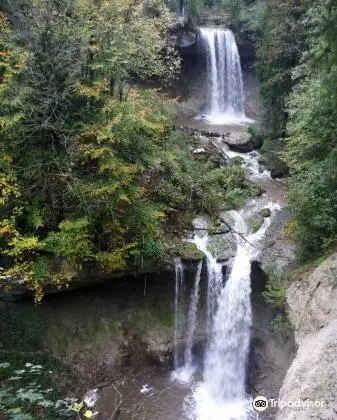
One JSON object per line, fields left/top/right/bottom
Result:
{"left": 255, "top": 0, "right": 337, "bottom": 259}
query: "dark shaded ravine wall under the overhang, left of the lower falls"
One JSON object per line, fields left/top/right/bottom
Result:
{"left": 0, "top": 273, "right": 178, "bottom": 397}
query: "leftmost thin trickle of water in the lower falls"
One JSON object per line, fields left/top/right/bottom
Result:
{"left": 174, "top": 258, "right": 184, "bottom": 369}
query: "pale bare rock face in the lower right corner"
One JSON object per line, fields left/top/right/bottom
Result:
{"left": 276, "top": 253, "right": 337, "bottom": 420}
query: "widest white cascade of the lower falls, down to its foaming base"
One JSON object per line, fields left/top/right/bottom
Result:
{"left": 186, "top": 212, "right": 254, "bottom": 420}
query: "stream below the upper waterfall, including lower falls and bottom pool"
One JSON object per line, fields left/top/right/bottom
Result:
{"left": 94, "top": 144, "right": 283, "bottom": 420}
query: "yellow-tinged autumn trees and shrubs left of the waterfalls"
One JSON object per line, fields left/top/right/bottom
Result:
{"left": 0, "top": 0, "right": 255, "bottom": 300}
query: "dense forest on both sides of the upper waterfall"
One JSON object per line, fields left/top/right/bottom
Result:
{"left": 0, "top": 0, "right": 337, "bottom": 299}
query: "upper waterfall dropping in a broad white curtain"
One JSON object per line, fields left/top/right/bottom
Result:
{"left": 200, "top": 28, "right": 251, "bottom": 124}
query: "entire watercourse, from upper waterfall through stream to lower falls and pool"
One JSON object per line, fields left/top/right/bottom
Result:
{"left": 94, "top": 28, "right": 283, "bottom": 420}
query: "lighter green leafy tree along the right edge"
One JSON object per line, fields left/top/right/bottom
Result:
{"left": 282, "top": 1, "right": 337, "bottom": 258}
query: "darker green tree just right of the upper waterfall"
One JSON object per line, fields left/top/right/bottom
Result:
{"left": 256, "top": 0, "right": 307, "bottom": 139}
